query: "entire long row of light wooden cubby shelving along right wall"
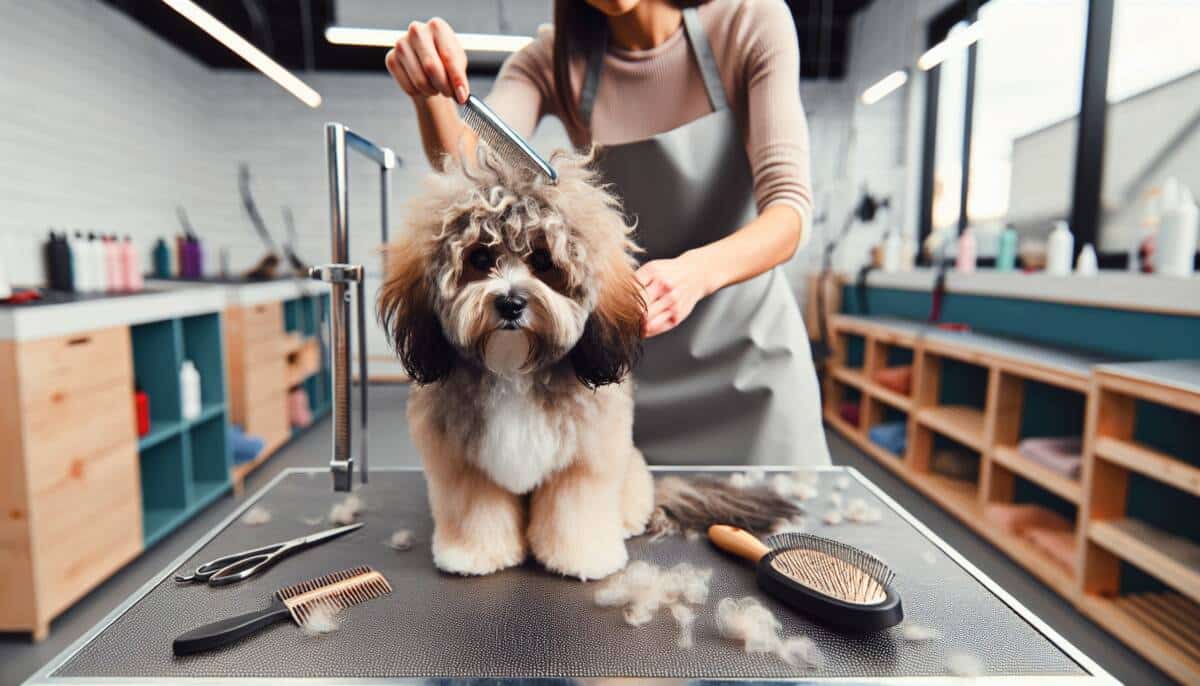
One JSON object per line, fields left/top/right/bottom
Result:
{"left": 826, "top": 315, "right": 1200, "bottom": 684}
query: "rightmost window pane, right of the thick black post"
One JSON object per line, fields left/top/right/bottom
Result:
{"left": 1099, "top": 0, "right": 1200, "bottom": 252}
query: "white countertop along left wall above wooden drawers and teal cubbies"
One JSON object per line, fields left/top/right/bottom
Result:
{"left": 0, "top": 279, "right": 328, "bottom": 341}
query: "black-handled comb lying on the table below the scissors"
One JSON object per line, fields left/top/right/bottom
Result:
{"left": 173, "top": 567, "right": 391, "bottom": 655}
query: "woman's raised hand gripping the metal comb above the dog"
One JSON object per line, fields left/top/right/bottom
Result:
{"left": 385, "top": 18, "right": 470, "bottom": 104}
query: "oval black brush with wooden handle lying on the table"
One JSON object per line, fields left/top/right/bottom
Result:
{"left": 708, "top": 524, "right": 904, "bottom": 633}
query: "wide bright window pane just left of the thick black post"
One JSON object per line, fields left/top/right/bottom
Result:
{"left": 966, "top": 0, "right": 1087, "bottom": 239}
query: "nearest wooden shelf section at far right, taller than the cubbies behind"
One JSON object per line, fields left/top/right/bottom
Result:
{"left": 1078, "top": 361, "right": 1200, "bottom": 684}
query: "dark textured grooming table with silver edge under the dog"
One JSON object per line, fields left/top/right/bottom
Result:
{"left": 26, "top": 468, "right": 1114, "bottom": 686}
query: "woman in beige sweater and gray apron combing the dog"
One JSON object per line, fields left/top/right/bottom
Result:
{"left": 388, "top": 0, "right": 829, "bottom": 464}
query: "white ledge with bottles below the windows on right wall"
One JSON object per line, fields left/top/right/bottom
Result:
{"left": 844, "top": 269, "right": 1200, "bottom": 317}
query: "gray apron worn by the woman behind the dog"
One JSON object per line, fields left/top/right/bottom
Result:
{"left": 580, "top": 8, "right": 829, "bottom": 465}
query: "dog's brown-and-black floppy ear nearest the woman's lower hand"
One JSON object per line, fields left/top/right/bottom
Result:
{"left": 569, "top": 261, "right": 646, "bottom": 389}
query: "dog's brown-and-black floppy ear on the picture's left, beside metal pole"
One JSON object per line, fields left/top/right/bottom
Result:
{"left": 376, "top": 243, "right": 457, "bottom": 384}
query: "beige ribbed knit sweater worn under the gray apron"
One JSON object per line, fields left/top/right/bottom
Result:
{"left": 487, "top": 0, "right": 812, "bottom": 236}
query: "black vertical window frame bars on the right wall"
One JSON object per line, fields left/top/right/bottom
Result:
{"left": 917, "top": 0, "right": 1116, "bottom": 264}
